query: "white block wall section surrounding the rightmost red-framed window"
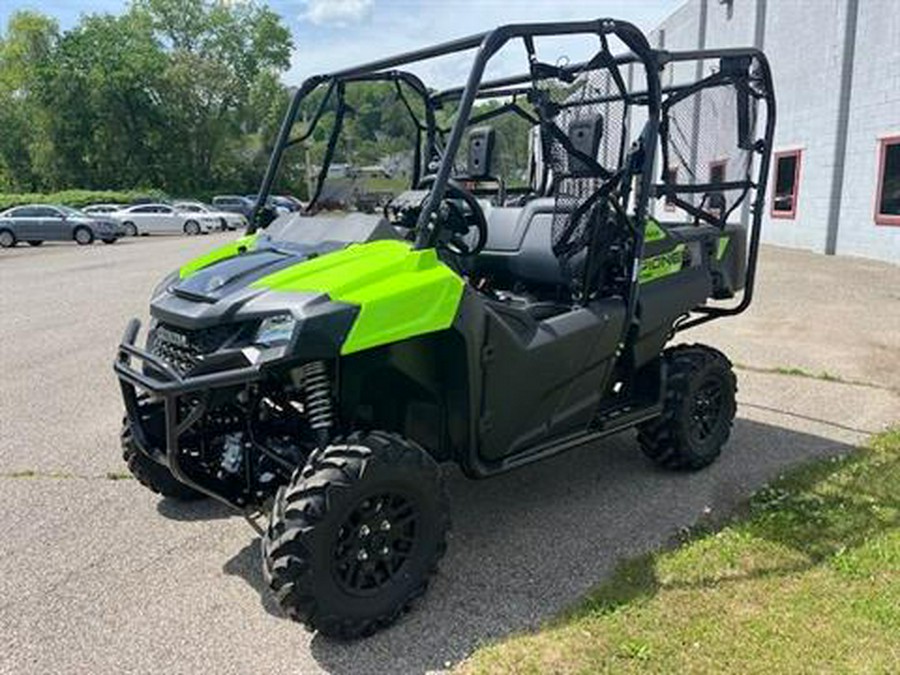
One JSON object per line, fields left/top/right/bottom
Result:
{"left": 837, "top": 0, "right": 900, "bottom": 262}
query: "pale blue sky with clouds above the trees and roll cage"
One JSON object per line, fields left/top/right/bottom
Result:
{"left": 0, "top": 0, "right": 684, "bottom": 87}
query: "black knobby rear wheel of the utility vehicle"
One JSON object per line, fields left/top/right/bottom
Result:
{"left": 638, "top": 345, "right": 737, "bottom": 470}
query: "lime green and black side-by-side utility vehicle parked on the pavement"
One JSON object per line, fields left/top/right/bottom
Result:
{"left": 115, "top": 19, "right": 775, "bottom": 638}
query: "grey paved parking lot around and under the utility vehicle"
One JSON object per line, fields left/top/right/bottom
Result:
{"left": 0, "top": 234, "right": 900, "bottom": 673}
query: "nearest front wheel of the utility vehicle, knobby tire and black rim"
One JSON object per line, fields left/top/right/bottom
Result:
{"left": 262, "top": 431, "right": 449, "bottom": 639}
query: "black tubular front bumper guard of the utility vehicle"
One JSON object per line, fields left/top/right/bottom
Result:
{"left": 113, "top": 319, "right": 262, "bottom": 509}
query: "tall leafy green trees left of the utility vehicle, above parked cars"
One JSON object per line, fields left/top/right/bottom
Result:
{"left": 0, "top": 0, "right": 292, "bottom": 194}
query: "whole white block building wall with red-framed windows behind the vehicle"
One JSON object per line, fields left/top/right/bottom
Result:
{"left": 650, "top": 0, "right": 900, "bottom": 262}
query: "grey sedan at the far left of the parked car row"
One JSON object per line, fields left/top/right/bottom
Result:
{"left": 0, "top": 204, "right": 124, "bottom": 248}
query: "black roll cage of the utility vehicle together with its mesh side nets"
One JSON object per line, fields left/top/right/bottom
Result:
{"left": 248, "top": 19, "right": 775, "bottom": 342}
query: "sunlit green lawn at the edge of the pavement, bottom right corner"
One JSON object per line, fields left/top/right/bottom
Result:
{"left": 459, "top": 427, "right": 900, "bottom": 674}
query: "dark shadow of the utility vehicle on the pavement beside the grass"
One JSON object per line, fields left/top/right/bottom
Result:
{"left": 225, "top": 420, "right": 854, "bottom": 674}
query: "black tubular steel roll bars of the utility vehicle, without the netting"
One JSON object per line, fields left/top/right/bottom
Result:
{"left": 247, "top": 19, "right": 775, "bottom": 341}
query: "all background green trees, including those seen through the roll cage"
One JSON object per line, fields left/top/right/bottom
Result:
{"left": 0, "top": 0, "right": 530, "bottom": 203}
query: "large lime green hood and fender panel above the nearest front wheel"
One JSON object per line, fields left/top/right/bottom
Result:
{"left": 252, "top": 240, "right": 464, "bottom": 354}
